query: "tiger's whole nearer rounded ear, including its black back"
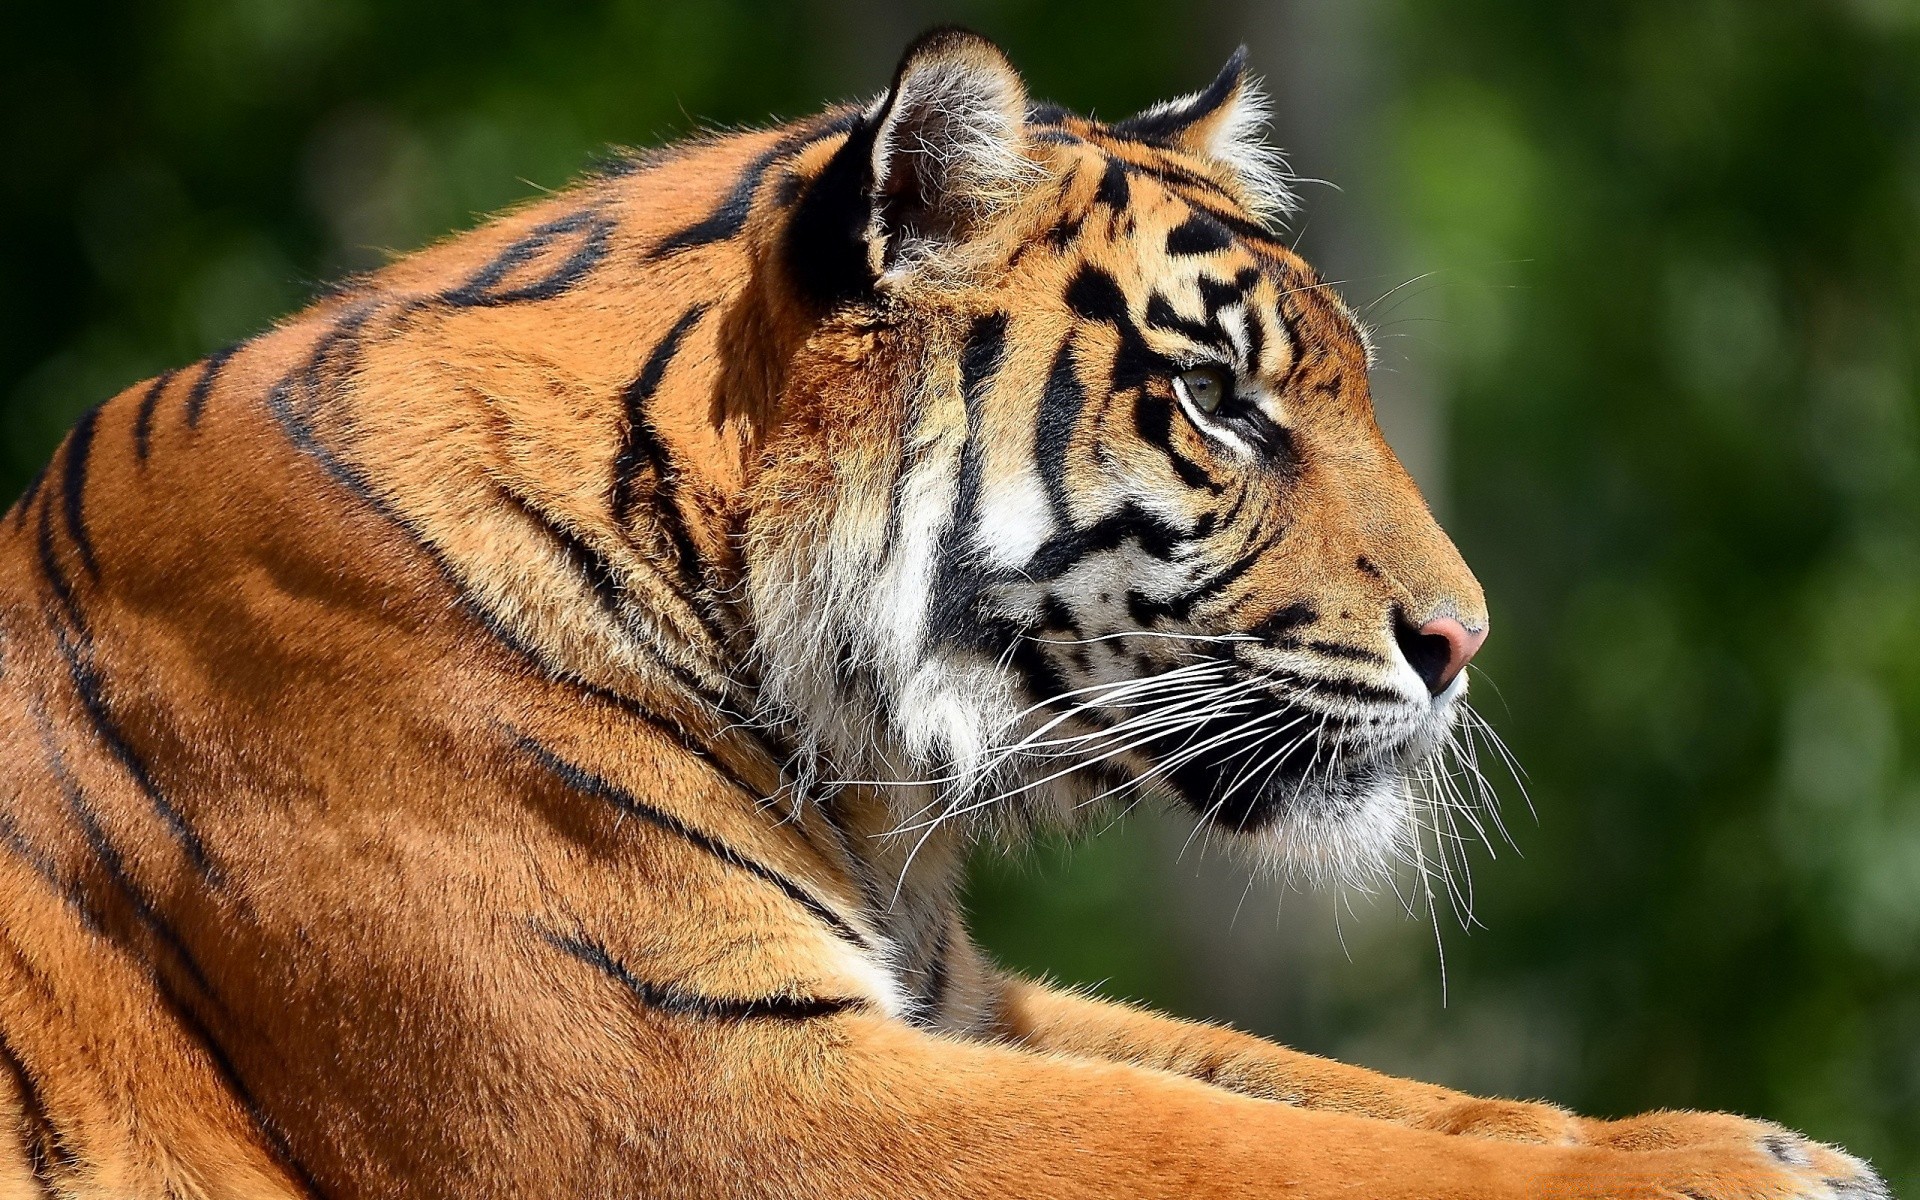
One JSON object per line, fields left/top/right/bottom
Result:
{"left": 787, "top": 29, "right": 1041, "bottom": 303}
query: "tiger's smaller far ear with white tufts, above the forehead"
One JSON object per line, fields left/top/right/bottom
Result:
{"left": 1114, "top": 46, "right": 1300, "bottom": 217}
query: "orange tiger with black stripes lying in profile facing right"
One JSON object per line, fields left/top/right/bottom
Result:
{"left": 0, "top": 29, "right": 1887, "bottom": 1200}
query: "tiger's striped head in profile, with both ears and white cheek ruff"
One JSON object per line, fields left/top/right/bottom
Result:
{"left": 745, "top": 31, "right": 1488, "bottom": 890}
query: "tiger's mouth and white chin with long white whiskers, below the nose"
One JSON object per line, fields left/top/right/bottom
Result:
{"left": 952, "top": 645, "right": 1465, "bottom": 883}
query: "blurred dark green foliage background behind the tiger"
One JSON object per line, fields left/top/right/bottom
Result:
{"left": 0, "top": 0, "right": 1920, "bottom": 1194}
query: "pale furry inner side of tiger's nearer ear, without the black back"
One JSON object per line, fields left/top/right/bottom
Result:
{"left": 866, "top": 29, "right": 1037, "bottom": 282}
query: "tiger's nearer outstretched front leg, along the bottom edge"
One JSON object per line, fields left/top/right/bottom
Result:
{"left": 587, "top": 1014, "right": 1868, "bottom": 1200}
